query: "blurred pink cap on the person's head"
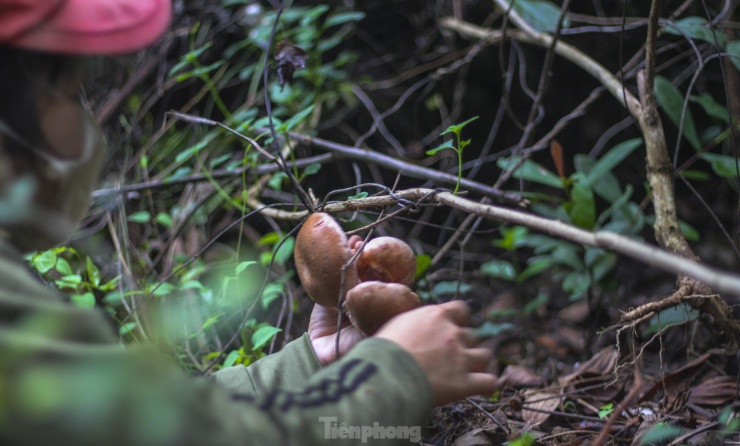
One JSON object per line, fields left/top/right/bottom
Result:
{"left": 0, "top": 0, "right": 171, "bottom": 54}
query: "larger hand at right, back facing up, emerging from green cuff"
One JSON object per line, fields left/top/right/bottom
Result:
{"left": 376, "top": 301, "right": 496, "bottom": 406}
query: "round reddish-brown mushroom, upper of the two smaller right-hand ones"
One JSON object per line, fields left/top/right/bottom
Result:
{"left": 357, "top": 237, "right": 416, "bottom": 287}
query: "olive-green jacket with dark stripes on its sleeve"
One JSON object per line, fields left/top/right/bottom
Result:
{"left": 0, "top": 240, "right": 432, "bottom": 446}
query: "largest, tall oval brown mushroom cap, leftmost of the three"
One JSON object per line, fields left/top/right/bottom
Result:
{"left": 293, "top": 212, "right": 358, "bottom": 307}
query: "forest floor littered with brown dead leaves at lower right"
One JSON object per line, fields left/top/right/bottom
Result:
{"left": 425, "top": 266, "right": 740, "bottom": 446}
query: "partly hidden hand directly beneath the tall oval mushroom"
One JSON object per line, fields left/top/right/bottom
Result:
{"left": 308, "top": 304, "right": 363, "bottom": 366}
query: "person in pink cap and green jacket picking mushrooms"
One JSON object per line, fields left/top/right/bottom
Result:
{"left": 0, "top": 0, "right": 494, "bottom": 446}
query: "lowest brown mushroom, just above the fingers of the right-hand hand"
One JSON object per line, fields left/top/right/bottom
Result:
{"left": 344, "top": 280, "right": 421, "bottom": 336}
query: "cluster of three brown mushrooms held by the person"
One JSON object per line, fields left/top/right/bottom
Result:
{"left": 294, "top": 212, "right": 420, "bottom": 336}
